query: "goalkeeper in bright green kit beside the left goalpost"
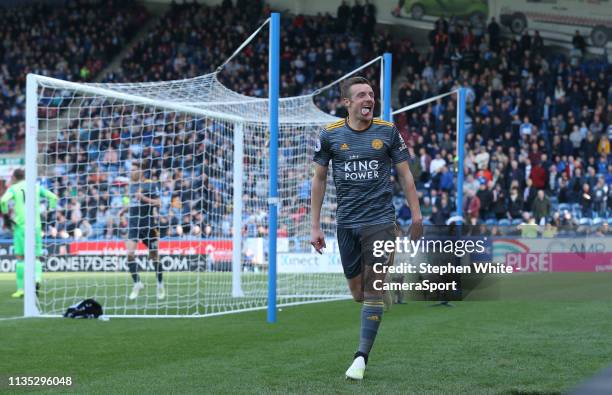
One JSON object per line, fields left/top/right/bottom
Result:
{"left": 0, "top": 169, "right": 57, "bottom": 298}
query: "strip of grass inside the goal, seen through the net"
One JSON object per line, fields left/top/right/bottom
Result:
{"left": 25, "top": 271, "right": 348, "bottom": 316}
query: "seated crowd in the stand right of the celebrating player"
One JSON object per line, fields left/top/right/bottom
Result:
{"left": 395, "top": 18, "right": 612, "bottom": 237}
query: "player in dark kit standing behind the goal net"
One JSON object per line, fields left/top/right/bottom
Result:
{"left": 125, "top": 162, "right": 166, "bottom": 300}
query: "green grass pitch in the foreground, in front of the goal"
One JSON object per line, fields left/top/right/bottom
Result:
{"left": 0, "top": 273, "right": 612, "bottom": 394}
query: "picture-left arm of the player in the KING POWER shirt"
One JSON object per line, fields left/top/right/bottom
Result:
{"left": 310, "top": 129, "right": 331, "bottom": 254}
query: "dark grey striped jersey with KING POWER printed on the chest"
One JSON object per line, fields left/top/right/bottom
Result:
{"left": 314, "top": 118, "right": 408, "bottom": 228}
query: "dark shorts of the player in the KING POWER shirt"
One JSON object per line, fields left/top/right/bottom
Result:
{"left": 337, "top": 223, "right": 398, "bottom": 279}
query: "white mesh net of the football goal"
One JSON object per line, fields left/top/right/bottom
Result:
{"left": 32, "top": 74, "right": 347, "bottom": 316}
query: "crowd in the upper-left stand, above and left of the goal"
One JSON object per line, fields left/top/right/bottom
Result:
{"left": 0, "top": 0, "right": 149, "bottom": 153}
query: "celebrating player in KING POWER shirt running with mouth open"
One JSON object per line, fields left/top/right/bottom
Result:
{"left": 311, "top": 77, "right": 423, "bottom": 380}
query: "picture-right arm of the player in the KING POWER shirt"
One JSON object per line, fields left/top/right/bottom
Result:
{"left": 391, "top": 127, "right": 423, "bottom": 240}
